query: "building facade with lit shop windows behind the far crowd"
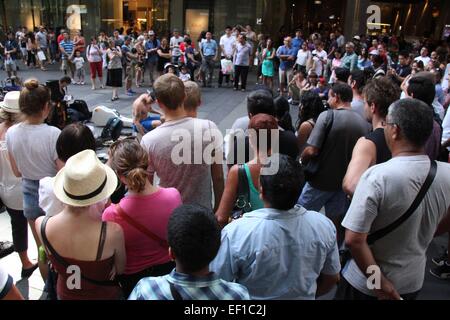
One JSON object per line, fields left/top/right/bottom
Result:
{"left": 0, "top": 0, "right": 450, "bottom": 39}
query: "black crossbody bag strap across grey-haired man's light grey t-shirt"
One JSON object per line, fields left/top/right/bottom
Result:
{"left": 339, "top": 160, "right": 437, "bottom": 267}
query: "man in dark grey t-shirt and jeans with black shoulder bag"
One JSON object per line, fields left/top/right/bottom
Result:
{"left": 299, "top": 83, "right": 368, "bottom": 225}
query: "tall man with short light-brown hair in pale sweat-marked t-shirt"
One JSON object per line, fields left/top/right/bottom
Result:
{"left": 141, "top": 74, "right": 224, "bottom": 209}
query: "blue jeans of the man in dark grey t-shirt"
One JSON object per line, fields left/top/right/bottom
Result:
{"left": 298, "top": 182, "right": 350, "bottom": 219}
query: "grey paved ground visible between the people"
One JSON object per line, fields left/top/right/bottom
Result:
{"left": 0, "top": 66, "right": 450, "bottom": 300}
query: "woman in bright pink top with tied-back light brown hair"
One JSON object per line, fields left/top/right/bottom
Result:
{"left": 103, "top": 139, "right": 181, "bottom": 297}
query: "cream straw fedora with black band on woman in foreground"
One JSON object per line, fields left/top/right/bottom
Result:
{"left": 53, "top": 150, "right": 117, "bottom": 207}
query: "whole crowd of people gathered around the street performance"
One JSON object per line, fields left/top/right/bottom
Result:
{"left": 0, "top": 22, "right": 450, "bottom": 300}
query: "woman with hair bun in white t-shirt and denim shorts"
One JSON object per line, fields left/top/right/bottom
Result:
{"left": 6, "top": 79, "right": 63, "bottom": 280}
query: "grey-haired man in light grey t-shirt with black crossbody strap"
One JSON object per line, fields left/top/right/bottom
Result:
{"left": 336, "top": 99, "right": 450, "bottom": 300}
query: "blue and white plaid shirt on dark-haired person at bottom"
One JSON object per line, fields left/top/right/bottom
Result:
{"left": 128, "top": 269, "right": 250, "bottom": 300}
